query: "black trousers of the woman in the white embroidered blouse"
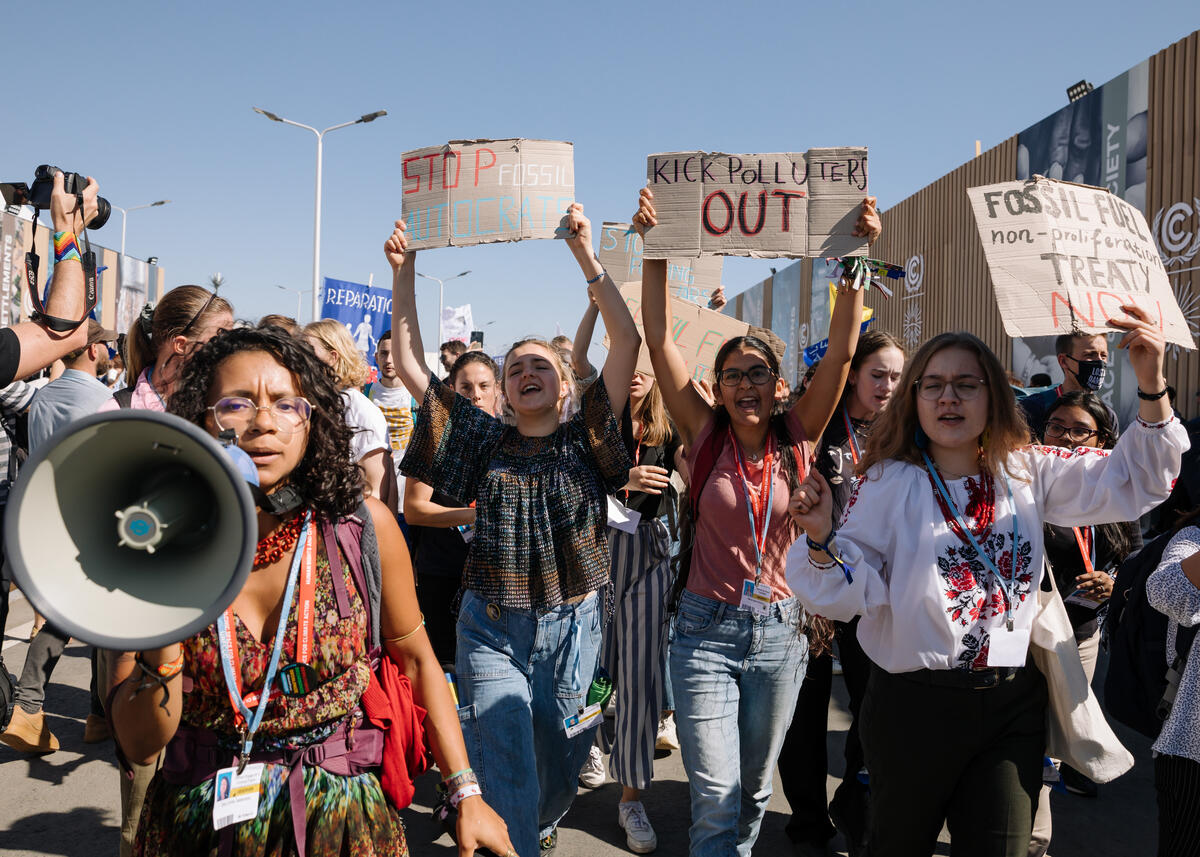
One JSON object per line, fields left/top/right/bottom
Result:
{"left": 859, "top": 666, "right": 1046, "bottom": 857}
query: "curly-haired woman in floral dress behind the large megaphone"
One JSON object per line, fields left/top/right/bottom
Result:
{"left": 109, "top": 328, "right": 515, "bottom": 857}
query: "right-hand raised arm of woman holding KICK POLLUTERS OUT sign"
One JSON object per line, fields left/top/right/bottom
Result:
{"left": 792, "top": 197, "right": 881, "bottom": 439}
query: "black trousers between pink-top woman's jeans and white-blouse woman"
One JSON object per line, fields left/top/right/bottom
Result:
{"left": 779, "top": 618, "right": 871, "bottom": 843}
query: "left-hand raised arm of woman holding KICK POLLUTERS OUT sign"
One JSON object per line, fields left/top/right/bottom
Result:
{"left": 634, "top": 187, "right": 713, "bottom": 447}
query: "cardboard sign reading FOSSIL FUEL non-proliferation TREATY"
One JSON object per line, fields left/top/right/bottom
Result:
{"left": 967, "top": 176, "right": 1195, "bottom": 348}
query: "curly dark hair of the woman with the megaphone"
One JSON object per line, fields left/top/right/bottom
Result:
{"left": 167, "top": 325, "right": 362, "bottom": 519}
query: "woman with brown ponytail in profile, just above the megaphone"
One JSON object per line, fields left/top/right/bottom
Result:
{"left": 100, "top": 286, "right": 233, "bottom": 410}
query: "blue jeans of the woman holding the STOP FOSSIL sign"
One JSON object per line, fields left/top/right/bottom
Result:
{"left": 455, "top": 591, "right": 604, "bottom": 857}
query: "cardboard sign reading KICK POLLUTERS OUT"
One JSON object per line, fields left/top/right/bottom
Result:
{"left": 644, "top": 148, "right": 868, "bottom": 259}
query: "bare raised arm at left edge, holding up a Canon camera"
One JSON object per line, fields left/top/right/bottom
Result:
{"left": 8, "top": 173, "right": 100, "bottom": 384}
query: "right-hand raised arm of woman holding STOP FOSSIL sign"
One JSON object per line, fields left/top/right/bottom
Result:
{"left": 566, "top": 203, "right": 642, "bottom": 415}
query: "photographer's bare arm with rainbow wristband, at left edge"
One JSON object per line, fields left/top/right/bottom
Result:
{"left": 0, "top": 172, "right": 100, "bottom": 386}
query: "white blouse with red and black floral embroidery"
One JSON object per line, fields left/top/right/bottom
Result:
{"left": 787, "top": 418, "right": 1188, "bottom": 673}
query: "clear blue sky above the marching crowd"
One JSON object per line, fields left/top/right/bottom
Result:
{"left": 0, "top": 0, "right": 1200, "bottom": 350}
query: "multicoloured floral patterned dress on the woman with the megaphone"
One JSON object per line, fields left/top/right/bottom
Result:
{"left": 134, "top": 530, "right": 408, "bottom": 857}
